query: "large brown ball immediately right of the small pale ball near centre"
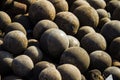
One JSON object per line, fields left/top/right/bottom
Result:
{"left": 81, "top": 33, "right": 107, "bottom": 53}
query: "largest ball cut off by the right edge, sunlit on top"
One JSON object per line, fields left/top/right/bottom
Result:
{"left": 100, "top": 20, "right": 120, "bottom": 44}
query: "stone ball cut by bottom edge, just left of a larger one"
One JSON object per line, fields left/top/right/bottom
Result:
{"left": 39, "top": 67, "right": 62, "bottom": 80}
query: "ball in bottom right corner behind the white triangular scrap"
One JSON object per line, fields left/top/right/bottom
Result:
{"left": 103, "top": 66, "right": 120, "bottom": 80}
